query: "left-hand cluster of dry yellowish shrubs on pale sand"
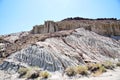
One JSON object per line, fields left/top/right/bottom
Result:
{"left": 18, "top": 67, "right": 50, "bottom": 79}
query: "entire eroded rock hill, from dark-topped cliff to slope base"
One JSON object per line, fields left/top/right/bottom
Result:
{"left": 0, "top": 18, "right": 120, "bottom": 75}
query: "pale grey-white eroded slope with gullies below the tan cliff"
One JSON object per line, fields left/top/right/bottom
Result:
{"left": 0, "top": 28, "right": 120, "bottom": 71}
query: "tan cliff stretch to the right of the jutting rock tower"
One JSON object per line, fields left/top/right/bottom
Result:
{"left": 58, "top": 20, "right": 120, "bottom": 36}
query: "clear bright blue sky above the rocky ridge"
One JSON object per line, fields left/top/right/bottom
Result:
{"left": 0, "top": 0, "right": 120, "bottom": 34}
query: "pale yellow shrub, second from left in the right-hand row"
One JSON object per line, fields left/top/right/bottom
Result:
{"left": 75, "top": 65, "right": 88, "bottom": 75}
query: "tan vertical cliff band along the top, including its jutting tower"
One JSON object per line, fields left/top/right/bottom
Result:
{"left": 31, "top": 20, "right": 120, "bottom": 36}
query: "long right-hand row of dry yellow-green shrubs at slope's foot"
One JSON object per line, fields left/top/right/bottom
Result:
{"left": 65, "top": 61, "right": 120, "bottom": 76}
